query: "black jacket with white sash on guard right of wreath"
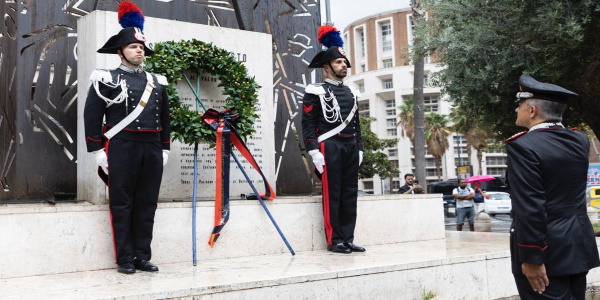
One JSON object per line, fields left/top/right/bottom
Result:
{"left": 302, "top": 83, "right": 363, "bottom": 151}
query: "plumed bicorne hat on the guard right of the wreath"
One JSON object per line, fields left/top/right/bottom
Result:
{"left": 308, "top": 25, "right": 352, "bottom": 68}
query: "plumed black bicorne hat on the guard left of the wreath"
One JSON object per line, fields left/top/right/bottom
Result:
{"left": 98, "top": 1, "right": 154, "bottom": 56}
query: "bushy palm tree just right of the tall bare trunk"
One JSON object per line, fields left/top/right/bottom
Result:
{"left": 425, "top": 113, "right": 451, "bottom": 180}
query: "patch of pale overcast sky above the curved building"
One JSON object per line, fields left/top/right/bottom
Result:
{"left": 321, "top": 0, "right": 410, "bottom": 31}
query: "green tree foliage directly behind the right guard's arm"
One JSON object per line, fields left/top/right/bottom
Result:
{"left": 358, "top": 118, "right": 399, "bottom": 179}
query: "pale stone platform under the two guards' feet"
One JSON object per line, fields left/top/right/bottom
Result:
{"left": 0, "top": 232, "right": 552, "bottom": 300}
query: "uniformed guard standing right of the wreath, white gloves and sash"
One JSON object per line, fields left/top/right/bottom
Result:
{"left": 302, "top": 26, "right": 365, "bottom": 253}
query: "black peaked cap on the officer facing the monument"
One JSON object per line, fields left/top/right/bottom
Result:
{"left": 515, "top": 74, "right": 579, "bottom": 104}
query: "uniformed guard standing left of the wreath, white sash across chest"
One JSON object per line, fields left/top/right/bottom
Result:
{"left": 84, "top": 5, "right": 170, "bottom": 274}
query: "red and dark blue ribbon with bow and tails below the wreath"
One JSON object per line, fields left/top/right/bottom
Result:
{"left": 202, "top": 108, "right": 275, "bottom": 247}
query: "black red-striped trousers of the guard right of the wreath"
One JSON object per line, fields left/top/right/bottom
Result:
{"left": 320, "top": 137, "right": 358, "bottom": 245}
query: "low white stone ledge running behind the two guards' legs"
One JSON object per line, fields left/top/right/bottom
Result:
{"left": 0, "top": 195, "right": 444, "bottom": 279}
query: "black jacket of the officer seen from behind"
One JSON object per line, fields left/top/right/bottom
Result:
{"left": 506, "top": 127, "right": 600, "bottom": 276}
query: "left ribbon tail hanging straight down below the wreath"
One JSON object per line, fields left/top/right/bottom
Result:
{"left": 208, "top": 122, "right": 231, "bottom": 247}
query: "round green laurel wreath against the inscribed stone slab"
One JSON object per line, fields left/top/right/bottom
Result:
{"left": 145, "top": 39, "right": 260, "bottom": 145}
